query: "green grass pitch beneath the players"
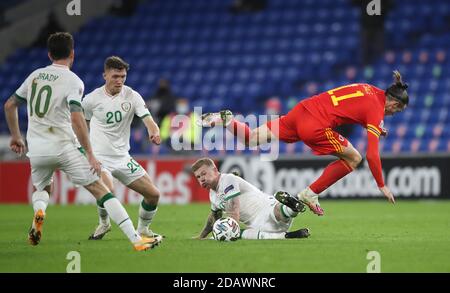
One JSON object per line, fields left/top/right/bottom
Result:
{"left": 0, "top": 200, "right": 450, "bottom": 272}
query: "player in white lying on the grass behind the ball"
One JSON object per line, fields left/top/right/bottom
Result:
{"left": 192, "top": 158, "right": 309, "bottom": 239}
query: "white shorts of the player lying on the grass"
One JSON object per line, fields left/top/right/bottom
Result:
{"left": 248, "top": 196, "right": 292, "bottom": 233}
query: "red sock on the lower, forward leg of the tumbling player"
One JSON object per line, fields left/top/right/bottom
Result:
{"left": 309, "top": 160, "right": 353, "bottom": 194}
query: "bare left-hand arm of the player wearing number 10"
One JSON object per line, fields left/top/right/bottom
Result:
{"left": 4, "top": 96, "right": 25, "bottom": 155}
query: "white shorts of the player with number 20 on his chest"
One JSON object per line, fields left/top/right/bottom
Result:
{"left": 96, "top": 154, "right": 147, "bottom": 186}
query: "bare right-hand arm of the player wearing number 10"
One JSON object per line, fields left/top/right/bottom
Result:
{"left": 70, "top": 111, "right": 101, "bottom": 176}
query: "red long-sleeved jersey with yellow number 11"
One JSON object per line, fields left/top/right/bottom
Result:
{"left": 298, "top": 83, "right": 386, "bottom": 187}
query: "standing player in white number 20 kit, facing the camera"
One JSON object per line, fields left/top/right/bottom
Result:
{"left": 82, "top": 56, "right": 162, "bottom": 240}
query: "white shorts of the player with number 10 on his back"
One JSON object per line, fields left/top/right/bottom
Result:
{"left": 30, "top": 145, "right": 100, "bottom": 191}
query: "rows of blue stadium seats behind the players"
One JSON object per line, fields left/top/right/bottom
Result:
{"left": 0, "top": 0, "right": 450, "bottom": 154}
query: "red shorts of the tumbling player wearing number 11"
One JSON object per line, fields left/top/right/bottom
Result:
{"left": 267, "top": 103, "right": 348, "bottom": 155}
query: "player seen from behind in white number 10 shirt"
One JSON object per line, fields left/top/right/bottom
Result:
{"left": 5, "top": 33, "right": 159, "bottom": 251}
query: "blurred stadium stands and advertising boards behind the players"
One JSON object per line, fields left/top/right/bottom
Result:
{"left": 0, "top": 0, "right": 450, "bottom": 271}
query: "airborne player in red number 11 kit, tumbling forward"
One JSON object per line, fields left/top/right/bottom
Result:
{"left": 201, "top": 71, "right": 409, "bottom": 216}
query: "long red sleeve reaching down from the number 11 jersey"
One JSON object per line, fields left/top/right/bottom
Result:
{"left": 366, "top": 112, "right": 385, "bottom": 187}
